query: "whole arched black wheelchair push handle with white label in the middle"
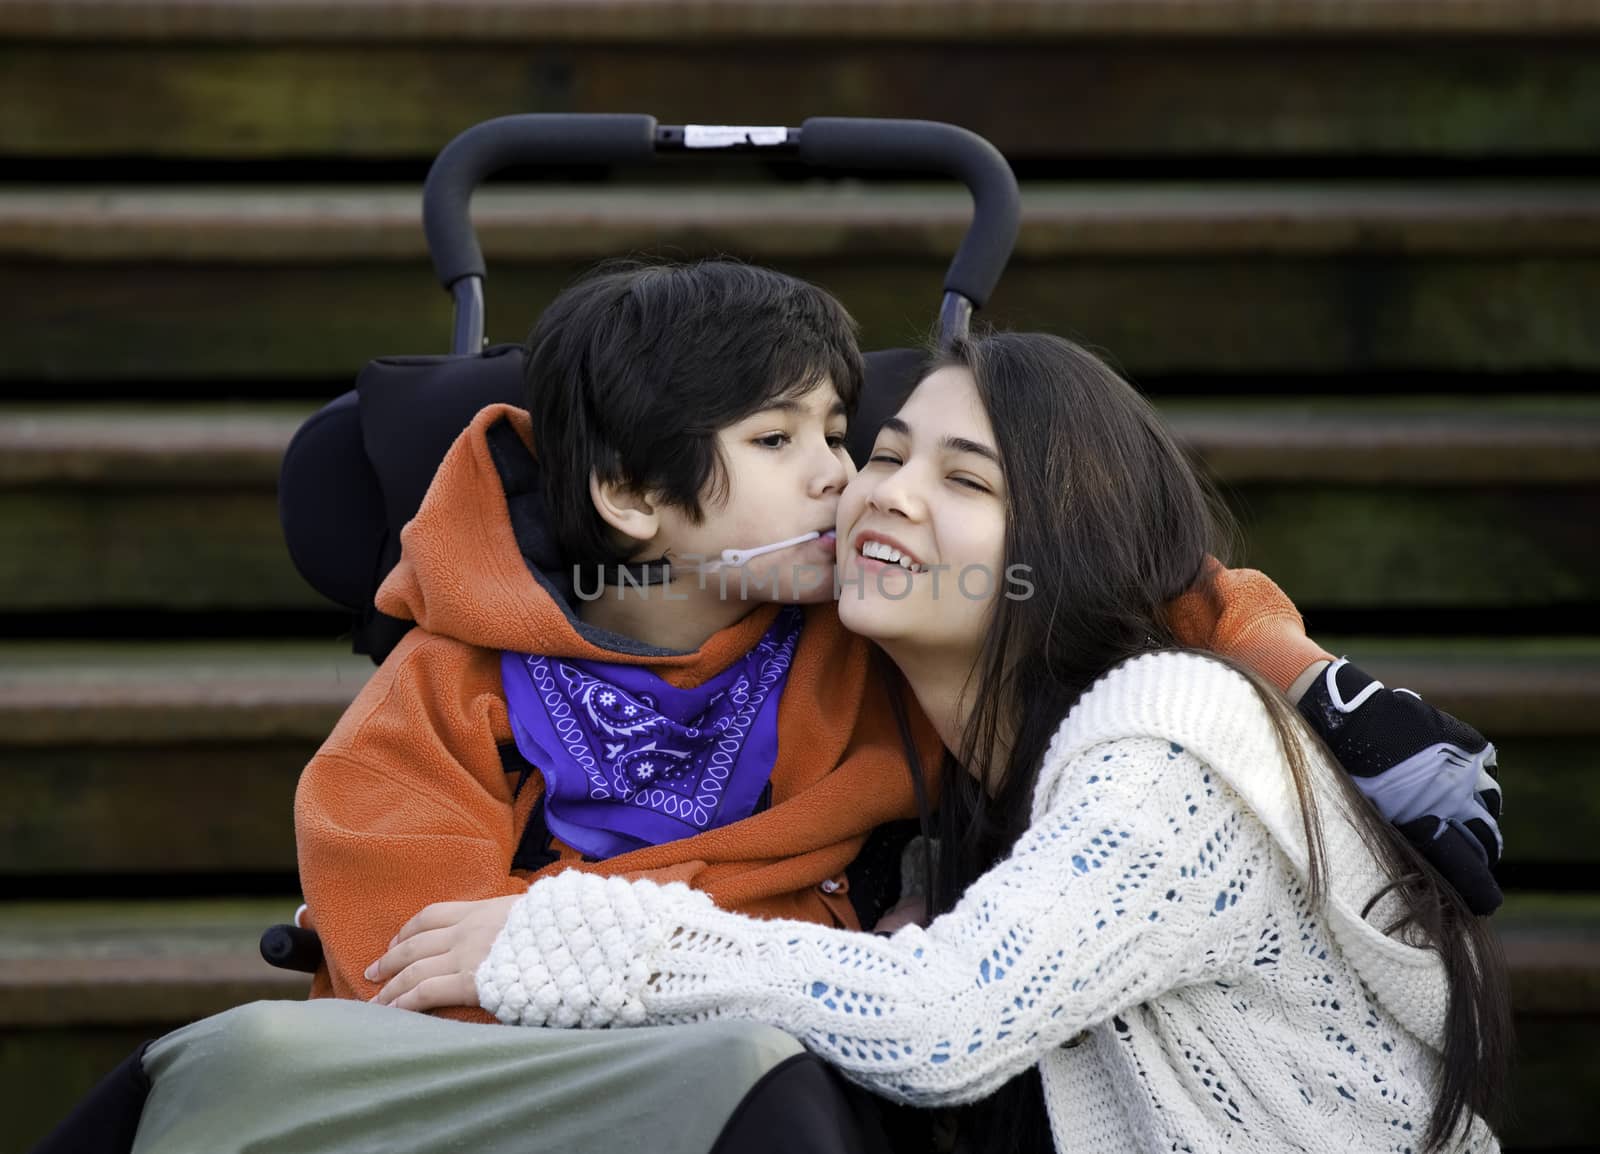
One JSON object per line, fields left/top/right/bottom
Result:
{"left": 422, "top": 114, "right": 1021, "bottom": 354}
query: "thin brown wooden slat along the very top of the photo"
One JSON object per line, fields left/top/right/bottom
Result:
{"left": 0, "top": 0, "right": 1600, "bottom": 42}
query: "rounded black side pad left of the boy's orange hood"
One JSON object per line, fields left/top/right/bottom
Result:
{"left": 278, "top": 389, "right": 386, "bottom": 611}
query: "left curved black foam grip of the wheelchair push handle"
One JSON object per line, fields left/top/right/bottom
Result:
{"left": 422, "top": 112, "right": 656, "bottom": 288}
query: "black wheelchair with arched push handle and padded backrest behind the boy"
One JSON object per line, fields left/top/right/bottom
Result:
{"left": 261, "top": 114, "right": 1021, "bottom": 973}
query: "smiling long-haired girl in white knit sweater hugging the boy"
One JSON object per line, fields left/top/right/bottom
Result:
{"left": 477, "top": 335, "right": 1509, "bottom": 1152}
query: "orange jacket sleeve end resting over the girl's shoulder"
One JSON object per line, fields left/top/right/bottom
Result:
{"left": 1166, "top": 559, "right": 1333, "bottom": 693}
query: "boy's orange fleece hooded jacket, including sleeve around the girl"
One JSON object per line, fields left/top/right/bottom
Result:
{"left": 294, "top": 405, "right": 1326, "bottom": 1021}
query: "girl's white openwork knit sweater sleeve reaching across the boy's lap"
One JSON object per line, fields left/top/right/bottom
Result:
{"left": 477, "top": 738, "right": 1270, "bottom": 1104}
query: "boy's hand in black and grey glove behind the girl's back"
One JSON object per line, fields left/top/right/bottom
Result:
{"left": 1299, "top": 659, "right": 1502, "bottom": 917}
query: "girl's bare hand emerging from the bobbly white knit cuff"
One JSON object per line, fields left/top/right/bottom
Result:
{"left": 366, "top": 893, "right": 522, "bottom": 1010}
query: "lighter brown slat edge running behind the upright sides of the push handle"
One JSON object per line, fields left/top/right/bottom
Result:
{"left": 0, "top": 181, "right": 1600, "bottom": 264}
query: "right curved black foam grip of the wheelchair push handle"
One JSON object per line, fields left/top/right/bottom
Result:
{"left": 800, "top": 117, "right": 1022, "bottom": 309}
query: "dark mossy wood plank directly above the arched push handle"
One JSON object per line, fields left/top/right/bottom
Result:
{"left": 0, "top": 39, "right": 1600, "bottom": 160}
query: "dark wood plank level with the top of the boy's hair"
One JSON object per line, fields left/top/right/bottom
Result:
{"left": 12, "top": 254, "right": 1600, "bottom": 376}
